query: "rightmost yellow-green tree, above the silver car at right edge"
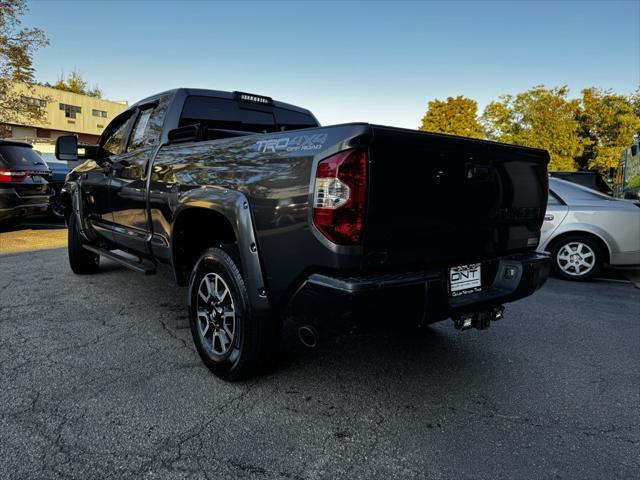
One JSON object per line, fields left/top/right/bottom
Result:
{"left": 576, "top": 88, "right": 640, "bottom": 174}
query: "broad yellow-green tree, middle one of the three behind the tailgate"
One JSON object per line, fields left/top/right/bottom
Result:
{"left": 481, "top": 86, "right": 586, "bottom": 170}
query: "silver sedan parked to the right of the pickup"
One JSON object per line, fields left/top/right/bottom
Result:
{"left": 538, "top": 178, "right": 640, "bottom": 280}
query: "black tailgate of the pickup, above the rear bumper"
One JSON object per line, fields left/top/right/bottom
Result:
{"left": 363, "top": 126, "right": 549, "bottom": 265}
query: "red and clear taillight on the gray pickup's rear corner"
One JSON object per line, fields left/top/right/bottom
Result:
{"left": 313, "top": 150, "right": 367, "bottom": 245}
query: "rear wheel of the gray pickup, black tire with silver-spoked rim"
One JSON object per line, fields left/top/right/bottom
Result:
{"left": 189, "top": 245, "right": 279, "bottom": 380}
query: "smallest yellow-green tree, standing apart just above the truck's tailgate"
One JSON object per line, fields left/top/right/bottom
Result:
{"left": 420, "top": 96, "right": 484, "bottom": 138}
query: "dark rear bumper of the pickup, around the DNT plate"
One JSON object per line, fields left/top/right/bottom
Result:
{"left": 287, "top": 253, "right": 550, "bottom": 333}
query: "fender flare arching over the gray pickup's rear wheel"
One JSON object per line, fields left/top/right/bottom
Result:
{"left": 170, "top": 187, "right": 271, "bottom": 312}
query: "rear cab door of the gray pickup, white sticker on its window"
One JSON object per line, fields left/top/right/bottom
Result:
{"left": 109, "top": 95, "right": 171, "bottom": 257}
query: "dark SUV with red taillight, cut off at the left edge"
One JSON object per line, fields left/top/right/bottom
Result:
{"left": 0, "top": 140, "right": 53, "bottom": 222}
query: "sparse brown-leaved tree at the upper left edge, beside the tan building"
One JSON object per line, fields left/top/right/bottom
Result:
{"left": 0, "top": 0, "right": 49, "bottom": 131}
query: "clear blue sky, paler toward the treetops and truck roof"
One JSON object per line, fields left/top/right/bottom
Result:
{"left": 24, "top": 0, "right": 640, "bottom": 128}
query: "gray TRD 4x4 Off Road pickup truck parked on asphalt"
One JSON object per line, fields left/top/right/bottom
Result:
{"left": 56, "top": 89, "right": 549, "bottom": 380}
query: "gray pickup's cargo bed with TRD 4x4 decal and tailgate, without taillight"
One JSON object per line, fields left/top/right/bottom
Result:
{"left": 150, "top": 123, "right": 549, "bottom": 303}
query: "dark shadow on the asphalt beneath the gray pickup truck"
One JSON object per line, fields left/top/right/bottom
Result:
{"left": 99, "top": 261, "right": 498, "bottom": 385}
